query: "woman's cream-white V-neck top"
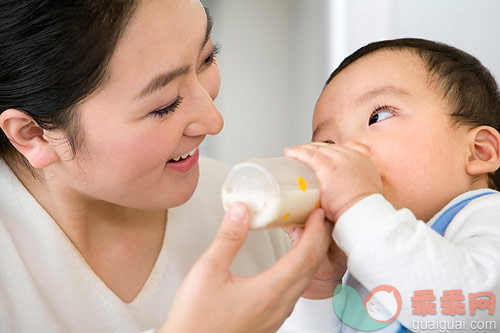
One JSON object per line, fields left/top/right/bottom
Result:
{"left": 0, "top": 158, "right": 289, "bottom": 333}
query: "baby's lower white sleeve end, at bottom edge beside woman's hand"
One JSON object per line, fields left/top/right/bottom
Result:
{"left": 278, "top": 297, "right": 341, "bottom": 333}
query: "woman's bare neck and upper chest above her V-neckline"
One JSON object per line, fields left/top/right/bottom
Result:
{"left": 8, "top": 163, "right": 167, "bottom": 303}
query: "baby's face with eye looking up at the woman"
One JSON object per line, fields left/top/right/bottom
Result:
{"left": 313, "top": 51, "right": 472, "bottom": 221}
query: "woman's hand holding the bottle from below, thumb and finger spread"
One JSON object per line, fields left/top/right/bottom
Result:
{"left": 159, "top": 203, "right": 332, "bottom": 333}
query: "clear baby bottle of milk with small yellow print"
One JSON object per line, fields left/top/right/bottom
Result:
{"left": 222, "top": 157, "right": 320, "bottom": 229}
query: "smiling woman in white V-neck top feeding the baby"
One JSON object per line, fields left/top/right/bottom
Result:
{"left": 0, "top": 0, "right": 338, "bottom": 332}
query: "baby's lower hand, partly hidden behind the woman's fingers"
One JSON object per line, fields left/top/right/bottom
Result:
{"left": 283, "top": 223, "right": 347, "bottom": 299}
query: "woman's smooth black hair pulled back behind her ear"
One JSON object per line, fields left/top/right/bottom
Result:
{"left": 0, "top": 0, "right": 136, "bottom": 166}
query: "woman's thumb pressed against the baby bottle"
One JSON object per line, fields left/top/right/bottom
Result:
{"left": 202, "top": 202, "right": 250, "bottom": 272}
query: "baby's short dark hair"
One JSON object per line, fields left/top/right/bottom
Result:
{"left": 325, "top": 38, "right": 500, "bottom": 190}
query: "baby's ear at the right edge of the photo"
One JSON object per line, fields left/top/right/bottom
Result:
{"left": 466, "top": 126, "right": 500, "bottom": 176}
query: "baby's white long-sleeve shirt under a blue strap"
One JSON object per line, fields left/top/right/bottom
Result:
{"left": 284, "top": 189, "right": 500, "bottom": 332}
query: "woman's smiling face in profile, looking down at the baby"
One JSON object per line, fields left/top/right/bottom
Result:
{"left": 50, "top": 0, "right": 223, "bottom": 209}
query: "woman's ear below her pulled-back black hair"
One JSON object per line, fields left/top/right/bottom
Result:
{"left": 0, "top": 109, "right": 59, "bottom": 169}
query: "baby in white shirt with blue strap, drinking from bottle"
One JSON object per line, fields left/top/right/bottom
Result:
{"left": 285, "top": 39, "right": 500, "bottom": 332}
